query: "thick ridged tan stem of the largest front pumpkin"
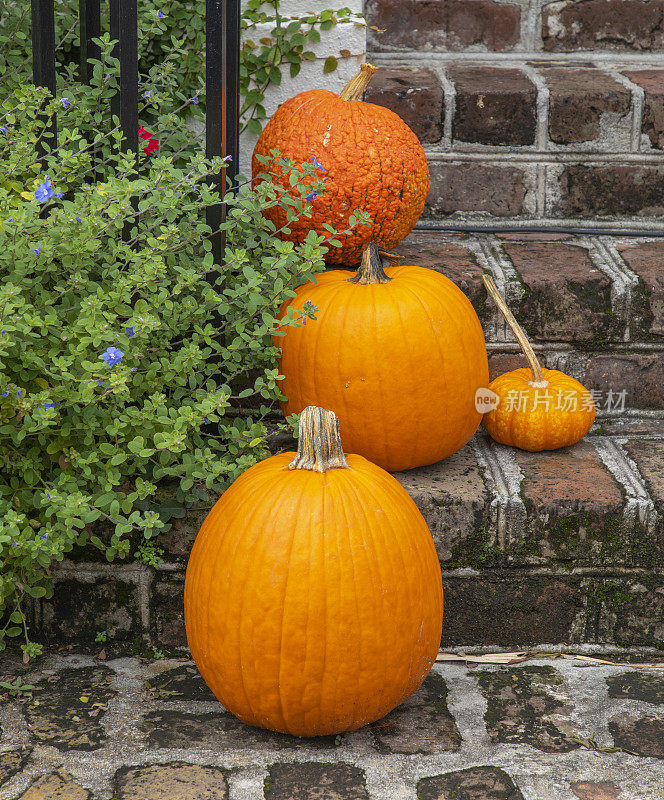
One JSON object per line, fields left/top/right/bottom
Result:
{"left": 288, "top": 406, "right": 349, "bottom": 472}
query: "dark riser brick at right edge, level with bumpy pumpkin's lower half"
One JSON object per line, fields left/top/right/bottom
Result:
{"left": 560, "top": 164, "right": 664, "bottom": 217}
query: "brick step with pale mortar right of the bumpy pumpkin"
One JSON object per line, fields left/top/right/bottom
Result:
{"left": 365, "top": 61, "right": 664, "bottom": 223}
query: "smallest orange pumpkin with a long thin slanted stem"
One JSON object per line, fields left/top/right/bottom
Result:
{"left": 483, "top": 275, "right": 596, "bottom": 452}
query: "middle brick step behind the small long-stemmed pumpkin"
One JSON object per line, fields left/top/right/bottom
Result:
{"left": 395, "top": 231, "right": 664, "bottom": 409}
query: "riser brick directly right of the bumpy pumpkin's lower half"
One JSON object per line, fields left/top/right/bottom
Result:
{"left": 427, "top": 163, "right": 526, "bottom": 217}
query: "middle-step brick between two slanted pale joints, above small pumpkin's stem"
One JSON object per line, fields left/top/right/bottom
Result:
{"left": 503, "top": 242, "right": 624, "bottom": 342}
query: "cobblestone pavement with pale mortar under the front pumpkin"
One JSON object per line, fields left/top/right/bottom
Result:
{"left": 0, "top": 653, "right": 664, "bottom": 800}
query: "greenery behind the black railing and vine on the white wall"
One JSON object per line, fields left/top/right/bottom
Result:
{"left": 0, "top": 0, "right": 364, "bottom": 132}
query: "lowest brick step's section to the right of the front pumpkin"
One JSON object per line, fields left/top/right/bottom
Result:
{"left": 397, "top": 432, "right": 664, "bottom": 649}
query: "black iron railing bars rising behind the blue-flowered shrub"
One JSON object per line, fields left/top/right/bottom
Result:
{"left": 31, "top": 0, "right": 240, "bottom": 264}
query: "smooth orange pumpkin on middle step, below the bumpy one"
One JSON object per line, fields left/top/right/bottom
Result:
{"left": 275, "top": 243, "right": 489, "bottom": 470}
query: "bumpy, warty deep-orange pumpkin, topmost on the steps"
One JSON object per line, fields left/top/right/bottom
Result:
{"left": 252, "top": 64, "right": 429, "bottom": 265}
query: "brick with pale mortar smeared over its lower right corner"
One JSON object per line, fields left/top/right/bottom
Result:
{"left": 541, "top": 68, "right": 632, "bottom": 144}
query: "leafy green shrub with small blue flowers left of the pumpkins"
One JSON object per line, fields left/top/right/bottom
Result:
{"left": 0, "top": 73, "right": 363, "bottom": 658}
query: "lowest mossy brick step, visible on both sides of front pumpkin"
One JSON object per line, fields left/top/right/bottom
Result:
{"left": 32, "top": 422, "right": 664, "bottom": 652}
